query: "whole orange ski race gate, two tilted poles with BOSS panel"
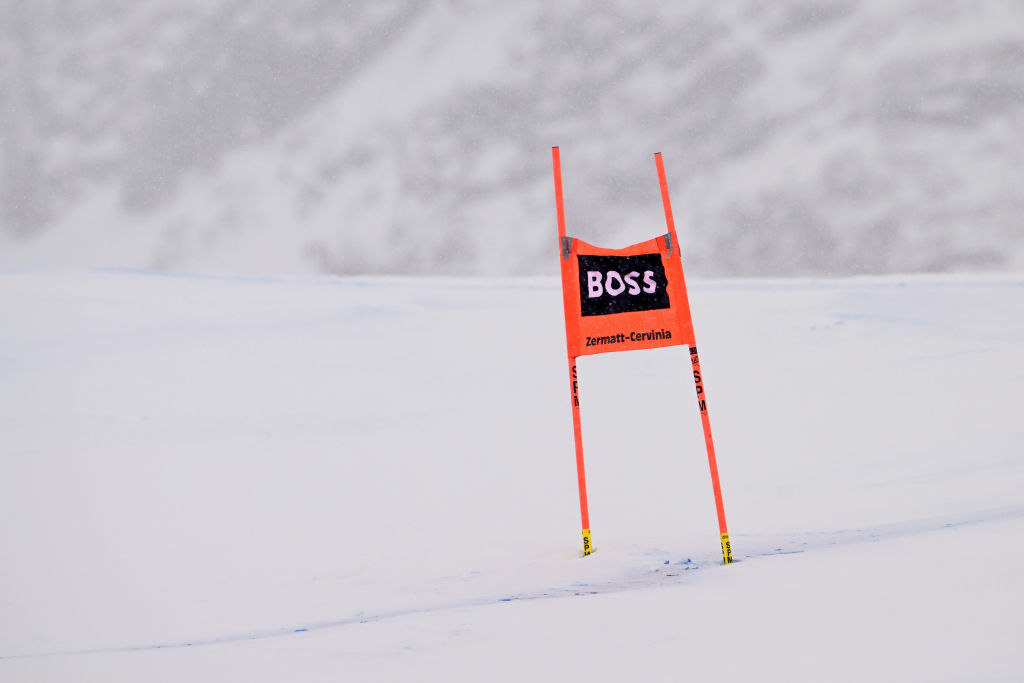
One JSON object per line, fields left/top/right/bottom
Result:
{"left": 551, "top": 147, "right": 732, "bottom": 564}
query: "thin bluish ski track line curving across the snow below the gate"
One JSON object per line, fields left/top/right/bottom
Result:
{"left": 0, "top": 506, "right": 1024, "bottom": 660}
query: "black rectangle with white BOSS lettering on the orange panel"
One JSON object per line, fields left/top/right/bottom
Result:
{"left": 577, "top": 254, "right": 670, "bottom": 315}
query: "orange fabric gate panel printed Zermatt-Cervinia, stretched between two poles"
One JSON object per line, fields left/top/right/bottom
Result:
{"left": 559, "top": 236, "right": 695, "bottom": 357}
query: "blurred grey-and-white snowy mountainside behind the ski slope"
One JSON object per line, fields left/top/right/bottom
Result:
{"left": 0, "top": 0, "right": 1024, "bottom": 276}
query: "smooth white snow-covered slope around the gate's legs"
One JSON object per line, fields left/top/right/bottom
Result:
{"left": 0, "top": 271, "right": 1024, "bottom": 681}
